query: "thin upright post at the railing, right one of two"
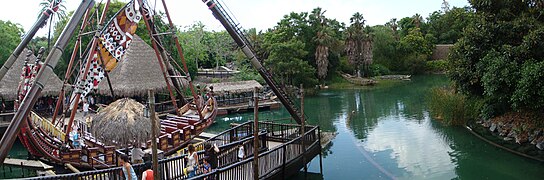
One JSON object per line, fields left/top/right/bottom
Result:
{"left": 253, "top": 87, "right": 259, "bottom": 180}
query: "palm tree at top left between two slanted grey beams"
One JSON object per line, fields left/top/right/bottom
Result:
{"left": 38, "top": 0, "right": 66, "bottom": 52}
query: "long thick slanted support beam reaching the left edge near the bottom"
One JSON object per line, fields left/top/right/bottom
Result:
{"left": 0, "top": 0, "right": 94, "bottom": 164}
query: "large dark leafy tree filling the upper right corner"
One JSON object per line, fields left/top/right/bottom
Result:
{"left": 449, "top": 0, "right": 544, "bottom": 117}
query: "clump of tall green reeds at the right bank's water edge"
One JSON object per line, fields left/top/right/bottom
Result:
{"left": 427, "top": 88, "right": 483, "bottom": 125}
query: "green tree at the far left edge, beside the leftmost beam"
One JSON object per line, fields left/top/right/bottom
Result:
{"left": 0, "top": 20, "right": 23, "bottom": 66}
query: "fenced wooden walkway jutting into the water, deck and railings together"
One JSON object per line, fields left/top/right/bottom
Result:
{"left": 25, "top": 122, "right": 321, "bottom": 179}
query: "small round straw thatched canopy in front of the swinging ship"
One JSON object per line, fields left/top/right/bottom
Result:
{"left": 91, "top": 98, "right": 160, "bottom": 146}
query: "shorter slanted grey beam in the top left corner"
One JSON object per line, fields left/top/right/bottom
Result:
{"left": 0, "top": 1, "right": 60, "bottom": 80}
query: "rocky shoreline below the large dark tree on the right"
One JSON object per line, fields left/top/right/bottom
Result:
{"left": 472, "top": 112, "right": 544, "bottom": 159}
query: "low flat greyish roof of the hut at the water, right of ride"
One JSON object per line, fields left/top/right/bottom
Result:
{"left": 208, "top": 80, "right": 263, "bottom": 94}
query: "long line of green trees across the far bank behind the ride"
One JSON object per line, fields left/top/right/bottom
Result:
{"left": 2, "top": 1, "right": 473, "bottom": 87}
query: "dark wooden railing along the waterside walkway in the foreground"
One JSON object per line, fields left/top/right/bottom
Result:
{"left": 25, "top": 122, "right": 319, "bottom": 180}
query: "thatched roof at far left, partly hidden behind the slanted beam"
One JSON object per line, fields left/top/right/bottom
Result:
{"left": 0, "top": 50, "right": 63, "bottom": 101}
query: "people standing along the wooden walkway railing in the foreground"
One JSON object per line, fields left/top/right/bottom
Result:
{"left": 119, "top": 143, "right": 219, "bottom": 180}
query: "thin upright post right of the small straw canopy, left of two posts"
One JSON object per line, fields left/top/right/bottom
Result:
{"left": 147, "top": 90, "right": 159, "bottom": 180}
